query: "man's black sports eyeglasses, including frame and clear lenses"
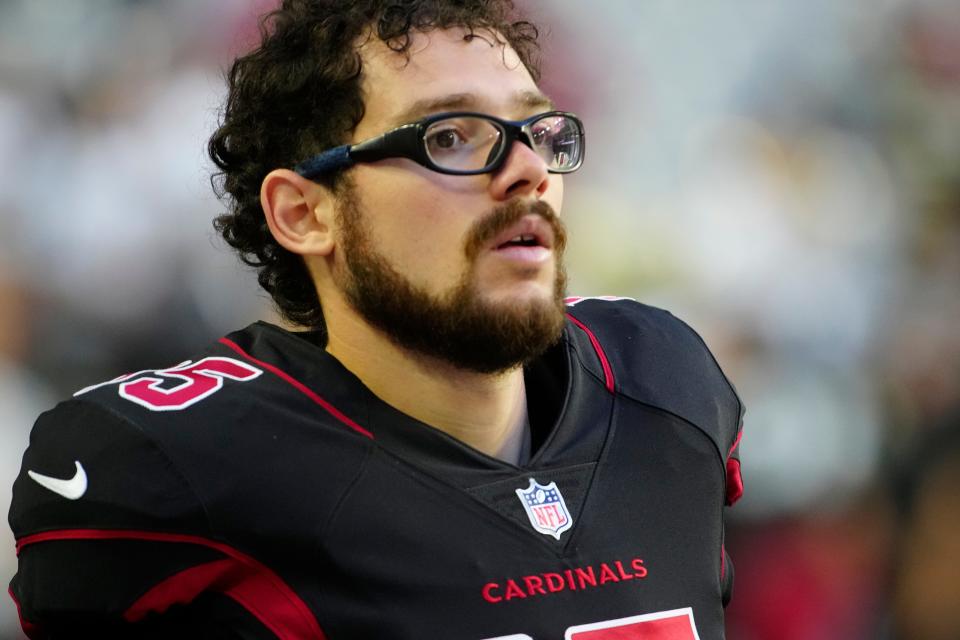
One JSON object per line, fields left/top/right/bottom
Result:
{"left": 294, "top": 111, "right": 584, "bottom": 178}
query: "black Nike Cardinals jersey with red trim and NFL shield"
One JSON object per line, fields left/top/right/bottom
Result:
{"left": 10, "top": 299, "right": 743, "bottom": 640}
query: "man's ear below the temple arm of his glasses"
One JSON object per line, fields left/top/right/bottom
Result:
{"left": 260, "top": 169, "right": 334, "bottom": 256}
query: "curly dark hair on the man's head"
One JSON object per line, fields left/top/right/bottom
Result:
{"left": 208, "top": 0, "right": 539, "bottom": 330}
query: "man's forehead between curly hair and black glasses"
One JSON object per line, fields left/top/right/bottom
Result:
{"left": 356, "top": 29, "right": 549, "bottom": 139}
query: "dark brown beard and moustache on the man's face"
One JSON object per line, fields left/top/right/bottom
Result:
{"left": 335, "top": 188, "right": 567, "bottom": 373}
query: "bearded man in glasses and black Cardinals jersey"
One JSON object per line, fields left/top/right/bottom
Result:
{"left": 11, "top": 0, "right": 742, "bottom": 640}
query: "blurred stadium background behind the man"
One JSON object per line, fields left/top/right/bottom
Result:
{"left": 0, "top": 0, "right": 960, "bottom": 640}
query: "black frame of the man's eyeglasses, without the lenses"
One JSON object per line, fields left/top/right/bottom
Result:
{"left": 294, "top": 111, "right": 586, "bottom": 178}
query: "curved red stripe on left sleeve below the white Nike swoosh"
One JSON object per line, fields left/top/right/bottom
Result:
{"left": 17, "top": 529, "right": 326, "bottom": 640}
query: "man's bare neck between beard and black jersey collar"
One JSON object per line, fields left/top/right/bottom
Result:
{"left": 324, "top": 296, "right": 527, "bottom": 461}
